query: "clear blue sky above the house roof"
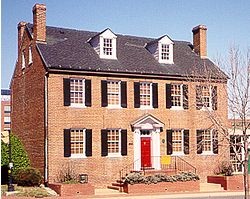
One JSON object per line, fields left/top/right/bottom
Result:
{"left": 0, "top": 0, "right": 250, "bottom": 88}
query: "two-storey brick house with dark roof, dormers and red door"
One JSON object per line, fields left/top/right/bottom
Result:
{"left": 11, "top": 4, "right": 229, "bottom": 187}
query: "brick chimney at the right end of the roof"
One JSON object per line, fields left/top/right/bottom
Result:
{"left": 192, "top": 25, "right": 207, "bottom": 58}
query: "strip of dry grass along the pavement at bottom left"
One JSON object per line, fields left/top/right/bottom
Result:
{"left": 1, "top": 185, "right": 51, "bottom": 197}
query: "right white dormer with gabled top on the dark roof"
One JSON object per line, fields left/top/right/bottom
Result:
{"left": 146, "top": 35, "right": 174, "bottom": 64}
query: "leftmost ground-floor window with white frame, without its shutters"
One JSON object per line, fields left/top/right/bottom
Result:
{"left": 70, "top": 129, "right": 86, "bottom": 158}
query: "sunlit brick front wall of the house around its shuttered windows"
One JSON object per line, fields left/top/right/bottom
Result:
{"left": 48, "top": 74, "right": 228, "bottom": 187}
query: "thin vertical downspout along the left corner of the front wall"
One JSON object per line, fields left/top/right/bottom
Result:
{"left": 44, "top": 72, "right": 48, "bottom": 186}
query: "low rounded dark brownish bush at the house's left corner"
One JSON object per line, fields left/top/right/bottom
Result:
{"left": 15, "top": 167, "right": 42, "bottom": 186}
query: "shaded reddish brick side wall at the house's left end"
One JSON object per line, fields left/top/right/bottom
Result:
{"left": 11, "top": 26, "right": 45, "bottom": 176}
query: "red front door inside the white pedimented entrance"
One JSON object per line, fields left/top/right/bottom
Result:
{"left": 141, "top": 137, "right": 151, "bottom": 167}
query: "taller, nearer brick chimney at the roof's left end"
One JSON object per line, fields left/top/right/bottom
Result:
{"left": 33, "top": 4, "right": 46, "bottom": 42}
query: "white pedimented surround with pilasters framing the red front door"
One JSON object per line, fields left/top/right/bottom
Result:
{"left": 131, "top": 114, "right": 164, "bottom": 171}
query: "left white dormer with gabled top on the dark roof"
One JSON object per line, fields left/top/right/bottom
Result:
{"left": 89, "top": 28, "right": 117, "bottom": 59}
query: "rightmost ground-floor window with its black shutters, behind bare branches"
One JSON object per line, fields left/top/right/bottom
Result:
{"left": 197, "top": 129, "right": 218, "bottom": 155}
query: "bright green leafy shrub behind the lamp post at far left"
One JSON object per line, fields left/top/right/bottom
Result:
{"left": 1, "top": 134, "right": 30, "bottom": 175}
